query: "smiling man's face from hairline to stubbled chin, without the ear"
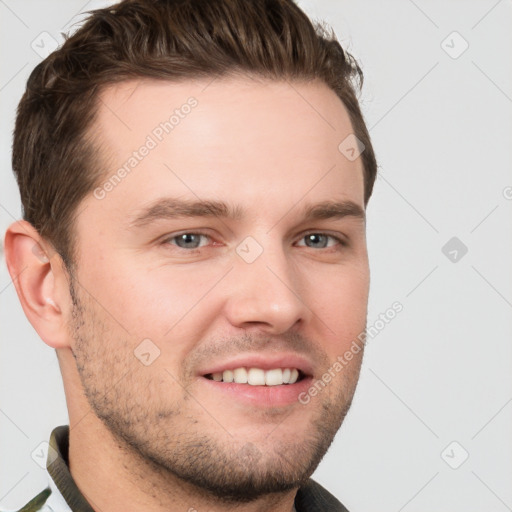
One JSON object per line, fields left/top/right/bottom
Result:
{"left": 72, "top": 78, "right": 369, "bottom": 499}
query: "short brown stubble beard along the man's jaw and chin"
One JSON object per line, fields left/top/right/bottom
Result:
{"left": 70, "top": 281, "right": 362, "bottom": 504}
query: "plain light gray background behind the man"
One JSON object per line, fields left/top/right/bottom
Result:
{"left": 0, "top": 0, "right": 512, "bottom": 512}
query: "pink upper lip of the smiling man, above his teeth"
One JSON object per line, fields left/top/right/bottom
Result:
{"left": 199, "top": 352, "right": 313, "bottom": 375}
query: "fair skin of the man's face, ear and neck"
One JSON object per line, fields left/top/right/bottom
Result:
{"left": 6, "top": 77, "right": 369, "bottom": 512}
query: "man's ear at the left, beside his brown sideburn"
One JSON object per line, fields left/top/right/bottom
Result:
{"left": 5, "top": 220, "right": 71, "bottom": 348}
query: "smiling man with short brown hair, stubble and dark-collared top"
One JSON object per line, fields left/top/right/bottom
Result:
{"left": 5, "top": 0, "right": 376, "bottom": 512}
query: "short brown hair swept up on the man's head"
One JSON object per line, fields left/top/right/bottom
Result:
{"left": 12, "top": 0, "right": 377, "bottom": 268}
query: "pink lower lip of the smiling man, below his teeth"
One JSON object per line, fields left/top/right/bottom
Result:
{"left": 201, "top": 377, "right": 313, "bottom": 408}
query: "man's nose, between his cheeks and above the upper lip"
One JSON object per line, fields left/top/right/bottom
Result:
{"left": 225, "top": 242, "right": 312, "bottom": 334}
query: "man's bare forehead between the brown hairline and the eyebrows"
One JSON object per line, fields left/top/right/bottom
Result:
{"left": 85, "top": 77, "right": 364, "bottom": 226}
